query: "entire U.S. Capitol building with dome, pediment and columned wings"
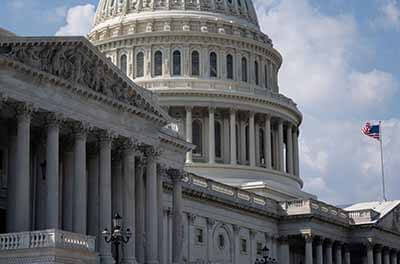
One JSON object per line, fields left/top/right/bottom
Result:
{"left": 0, "top": 0, "right": 400, "bottom": 264}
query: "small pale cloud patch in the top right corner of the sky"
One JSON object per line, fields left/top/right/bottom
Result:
{"left": 373, "top": 0, "right": 400, "bottom": 31}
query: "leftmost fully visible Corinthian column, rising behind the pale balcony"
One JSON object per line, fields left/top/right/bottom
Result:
{"left": 15, "top": 104, "right": 33, "bottom": 232}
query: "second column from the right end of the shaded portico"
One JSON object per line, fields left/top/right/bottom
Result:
{"left": 146, "top": 147, "right": 160, "bottom": 264}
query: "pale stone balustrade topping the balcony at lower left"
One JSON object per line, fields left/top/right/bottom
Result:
{"left": 0, "top": 229, "right": 95, "bottom": 252}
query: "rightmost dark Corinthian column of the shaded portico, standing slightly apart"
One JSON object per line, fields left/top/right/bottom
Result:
{"left": 167, "top": 169, "right": 183, "bottom": 264}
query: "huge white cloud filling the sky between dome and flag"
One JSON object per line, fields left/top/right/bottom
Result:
{"left": 255, "top": 0, "right": 400, "bottom": 204}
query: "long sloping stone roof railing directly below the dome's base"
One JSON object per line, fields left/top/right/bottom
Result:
{"left": 183, "top": 174, "right": 279, "bottom": 215}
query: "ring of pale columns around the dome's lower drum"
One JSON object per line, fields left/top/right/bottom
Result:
{"left": 185, "top": 106, "right": 299, "bottom": 176}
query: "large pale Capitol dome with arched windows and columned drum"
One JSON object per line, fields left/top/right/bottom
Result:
{"left": 88, "top": 0, "right": 310, "bottom": 200}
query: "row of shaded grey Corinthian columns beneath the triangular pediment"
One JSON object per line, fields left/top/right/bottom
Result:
{"left": 3, "top": 103, "right": 183, "bottom": 263}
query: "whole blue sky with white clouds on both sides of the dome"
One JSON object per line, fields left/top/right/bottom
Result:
{"left": 0, "top": 0, "right": 400, "bottom": 204}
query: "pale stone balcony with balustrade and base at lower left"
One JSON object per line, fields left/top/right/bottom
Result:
{"left": 0, "top": 229, "right": 97, "bottom": 264}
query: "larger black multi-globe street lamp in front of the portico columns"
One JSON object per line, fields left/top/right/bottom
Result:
{"left": 102, "top": 214, "right": 132, "bottom": 264}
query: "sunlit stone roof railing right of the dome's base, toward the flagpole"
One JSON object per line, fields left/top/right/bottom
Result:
{"left": 279, "top": 199, "right": 350, "bottom": 224}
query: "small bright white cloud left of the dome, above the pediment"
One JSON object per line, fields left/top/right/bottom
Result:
{"left": 56, "top": 4, "right": 95, "bottom": 36}
